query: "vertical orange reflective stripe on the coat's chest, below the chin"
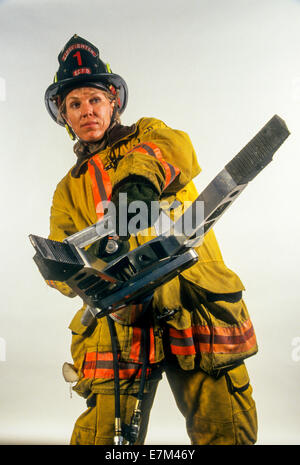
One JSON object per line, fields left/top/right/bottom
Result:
{"left": 88, "top": 155, "right": 112, "bottom": 219}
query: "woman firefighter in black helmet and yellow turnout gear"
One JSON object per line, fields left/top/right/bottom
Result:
{"left": 45, "top": 35, "right": 257, "bottom": 445}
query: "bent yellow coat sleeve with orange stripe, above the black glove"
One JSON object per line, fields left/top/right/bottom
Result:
{"left": 112, "top": 118, "right": 201, "bottom": 195}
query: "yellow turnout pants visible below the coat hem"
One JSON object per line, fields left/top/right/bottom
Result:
{"left": 71, "top": 362, "right": 257, "bottom": 445}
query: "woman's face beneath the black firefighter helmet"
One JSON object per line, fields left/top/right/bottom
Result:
{"left": 66, "top": 87, "right": 114, "bottom": 142}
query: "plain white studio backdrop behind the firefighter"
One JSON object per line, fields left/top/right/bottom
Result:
{"left": 0, "top": 0, "right": 300, "bottom": 444}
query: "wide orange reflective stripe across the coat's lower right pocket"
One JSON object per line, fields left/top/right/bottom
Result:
{"left": 169, "top": 320, "right": 256, "bottom": 355}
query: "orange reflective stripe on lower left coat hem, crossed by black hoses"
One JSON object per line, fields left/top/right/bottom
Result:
{"left": 83, "top": 352, "right": 152, "bottom": 379}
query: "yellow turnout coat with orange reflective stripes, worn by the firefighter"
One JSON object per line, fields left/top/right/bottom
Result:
{"left": 49, "top": 118, "right": 257, "bottom": 397}
